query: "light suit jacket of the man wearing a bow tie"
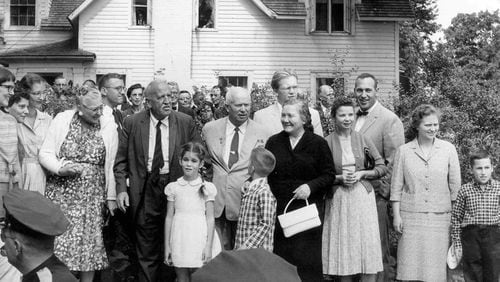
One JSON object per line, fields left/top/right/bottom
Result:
{"left": 359, "top": 102, "right": 405, "bottom": 198}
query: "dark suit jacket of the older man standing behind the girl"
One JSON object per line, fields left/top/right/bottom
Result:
{"left": 114, "top": 111, "right": 201, "bottom": 215}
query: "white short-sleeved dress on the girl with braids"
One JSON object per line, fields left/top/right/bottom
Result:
{"left": 165, "top": 177, "right": 221, "bottom": 268}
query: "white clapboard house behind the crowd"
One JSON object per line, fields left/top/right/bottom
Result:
{"left": 0, "top": 0, "right": 413, "bottom": 99}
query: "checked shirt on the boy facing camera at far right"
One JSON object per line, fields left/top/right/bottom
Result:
{"left": 451, "top": 179, "right": 500, "bottom": 249}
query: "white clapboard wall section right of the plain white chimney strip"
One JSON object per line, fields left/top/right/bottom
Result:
{"left": 192, "top": 0, "right": 399, "bottom": 99}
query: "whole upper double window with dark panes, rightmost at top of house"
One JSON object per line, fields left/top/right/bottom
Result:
{"left": 312, "top": 0, "right": 351, "bottom": 33}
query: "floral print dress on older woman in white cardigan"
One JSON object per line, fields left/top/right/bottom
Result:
{"left": 46, "top": 115, "right": 108, "bottom": 271}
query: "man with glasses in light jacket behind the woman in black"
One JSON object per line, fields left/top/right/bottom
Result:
{"left": 253, "top": 70, "right": 323, "bottom": 136}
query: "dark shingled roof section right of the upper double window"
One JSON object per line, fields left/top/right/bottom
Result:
{"left": 356, "top": 0, "right": 415, "bottom": 21}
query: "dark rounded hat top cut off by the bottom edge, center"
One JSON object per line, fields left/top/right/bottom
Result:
{"left": 192, "top": 249, "right": 300, "bottom": 282}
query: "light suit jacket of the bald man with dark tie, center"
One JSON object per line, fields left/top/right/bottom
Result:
{"left": 202, "top": 117, "right": 271, "bottom": 221}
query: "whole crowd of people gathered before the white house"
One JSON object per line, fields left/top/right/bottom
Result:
{"left": 0, "top": 68, "right": 500, "bottom": 282}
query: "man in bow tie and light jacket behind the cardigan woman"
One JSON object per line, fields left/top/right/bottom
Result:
{"left": 354, "top": 73, "right": 405, "bottom": 281}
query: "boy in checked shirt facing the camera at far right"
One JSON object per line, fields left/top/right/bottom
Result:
{"left": 451, "top": 151, "right": 500, "bottom": 282}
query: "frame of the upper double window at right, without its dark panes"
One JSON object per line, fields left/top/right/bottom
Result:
{"left": 309, "top": 0, "right": 355, "bottom": 35}
